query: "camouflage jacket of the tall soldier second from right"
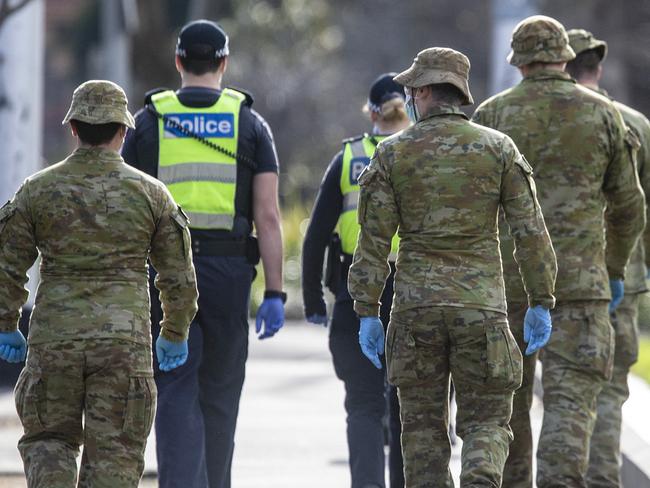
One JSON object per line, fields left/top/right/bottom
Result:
{"left": 472, "top": 70, "right": 645, "bottom": 302}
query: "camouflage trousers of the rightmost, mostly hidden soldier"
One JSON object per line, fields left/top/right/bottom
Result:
{"left": 587, "top": 294, "right": 639, "bottom": 488}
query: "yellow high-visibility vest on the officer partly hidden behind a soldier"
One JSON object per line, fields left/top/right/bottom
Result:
{"left": 338, "top": 134, "right": 399, "bottom": 255}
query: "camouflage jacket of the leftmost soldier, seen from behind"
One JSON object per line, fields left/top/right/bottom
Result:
{"left": 0, "top": 148, "right": 198, "bottom": 345}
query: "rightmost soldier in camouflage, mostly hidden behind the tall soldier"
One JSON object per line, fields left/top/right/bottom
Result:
{"left": 566, "top": 29, "right": 650, "bottom": 487}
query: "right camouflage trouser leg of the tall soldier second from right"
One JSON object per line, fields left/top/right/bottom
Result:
{"left": 537, "top": 300, "right": 614, "bottom": 488}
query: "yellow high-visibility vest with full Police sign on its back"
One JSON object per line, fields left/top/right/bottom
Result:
{"left": 151, "top": 88, "right": 245, "bottom": 230}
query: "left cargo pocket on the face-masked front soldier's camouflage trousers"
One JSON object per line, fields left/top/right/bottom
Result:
{"left": 386, "top": 322, "right": 422, "bottom": 387}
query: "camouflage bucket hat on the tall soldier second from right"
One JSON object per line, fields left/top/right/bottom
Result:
{"left": 508, "top": 15, "right": 576, "bottom": 66}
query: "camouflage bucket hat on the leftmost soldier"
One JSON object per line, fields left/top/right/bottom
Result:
{"left": 63, "top": 80, "right": 135, "bottom": 129}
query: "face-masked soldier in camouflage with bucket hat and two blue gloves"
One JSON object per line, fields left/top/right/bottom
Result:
{"left": 348, "top": 48, "right": 556, "bottom": 488}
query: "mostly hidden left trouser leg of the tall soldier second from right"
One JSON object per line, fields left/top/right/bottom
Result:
{"left": 503, "top": 303, "right": 538, "bottom": 488}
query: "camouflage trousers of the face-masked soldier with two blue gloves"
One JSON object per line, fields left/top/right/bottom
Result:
{"left": 386, "top": 307, "right": 522, "bottom": 488}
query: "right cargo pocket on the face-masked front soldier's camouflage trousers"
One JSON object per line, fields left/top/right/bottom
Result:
{"left": 485, "top": 324, "right": 523, "bottom": 391}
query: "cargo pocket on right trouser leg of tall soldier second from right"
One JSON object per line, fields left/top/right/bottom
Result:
{"left": 577, "top": 314, "right": 615, "bottom": 381}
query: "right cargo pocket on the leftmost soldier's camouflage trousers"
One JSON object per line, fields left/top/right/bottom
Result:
{"left": 123, "top": 376, "right": 156, "bottom": 439}
